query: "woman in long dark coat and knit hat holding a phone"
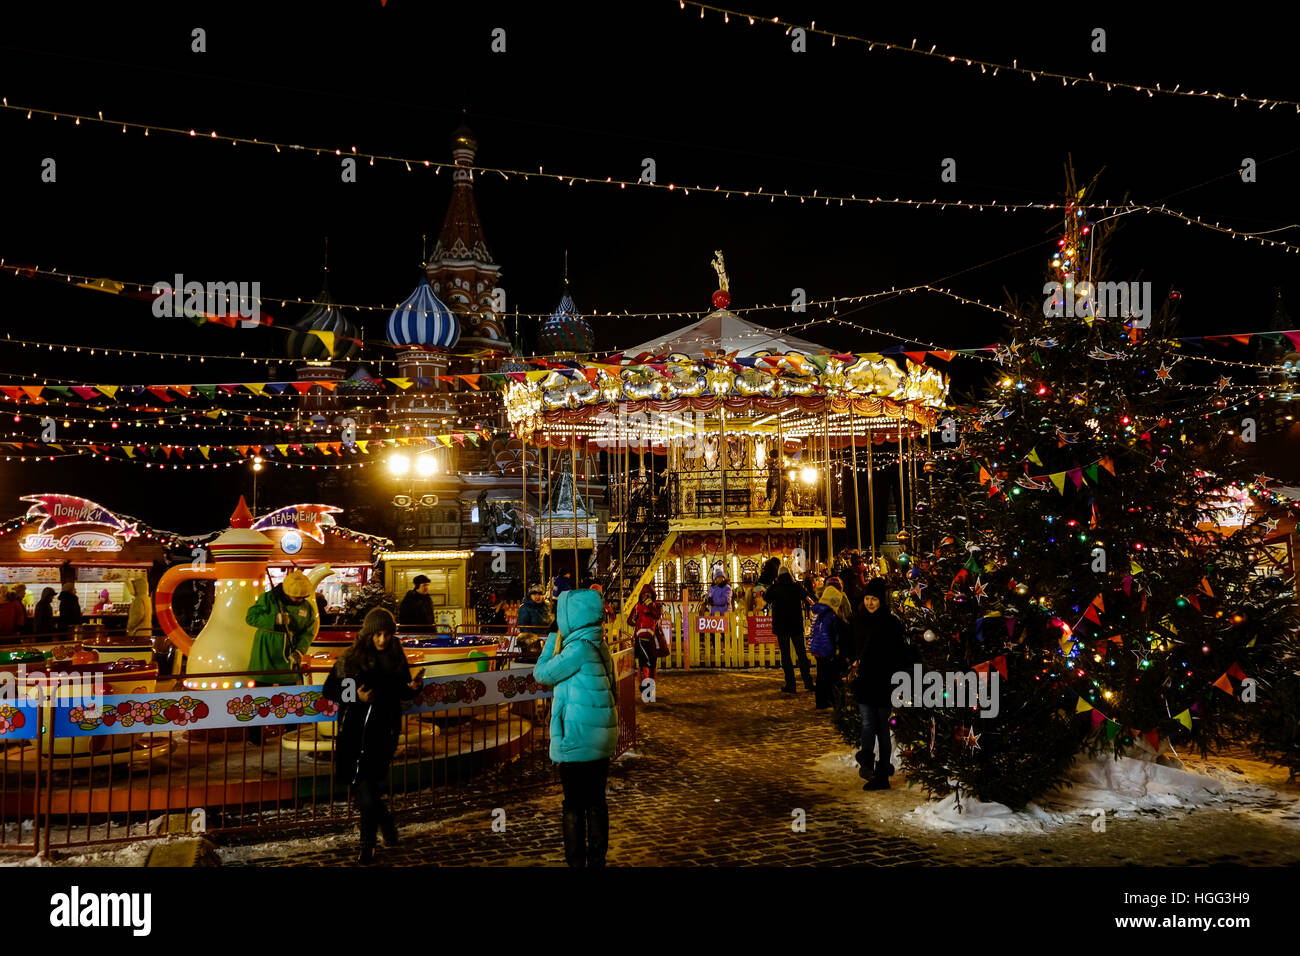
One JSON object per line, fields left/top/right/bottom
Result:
{"left": 322, "top": 607, "right": 424, "bottom": 864}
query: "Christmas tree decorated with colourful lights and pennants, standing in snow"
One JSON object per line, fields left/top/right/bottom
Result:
{"left": 894, "top": 170, "right": 1295, "bottom": 808}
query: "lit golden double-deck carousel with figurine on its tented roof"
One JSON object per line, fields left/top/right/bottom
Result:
{"left": 504, "top": 252, "right": 948, "bottom": 666}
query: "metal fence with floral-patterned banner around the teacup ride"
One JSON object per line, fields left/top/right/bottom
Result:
{"left": 0, "top": 652, "right": 636, "bottom": 855}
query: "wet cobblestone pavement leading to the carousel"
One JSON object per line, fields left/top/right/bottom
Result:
{"left": 218, "top": 671, "right": 1300, "bottom": 866}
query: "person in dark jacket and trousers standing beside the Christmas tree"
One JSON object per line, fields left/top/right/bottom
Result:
{"left": 852, "top": 578, "right": 911, "bottom": 790}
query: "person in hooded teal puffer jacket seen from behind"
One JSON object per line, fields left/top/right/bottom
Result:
{"left": 533, "top": 591, "right": 619, "bottom": 866}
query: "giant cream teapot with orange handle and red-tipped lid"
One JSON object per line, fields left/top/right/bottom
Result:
{"left": 153, "top": 497, "right": 332, "bottom": 689}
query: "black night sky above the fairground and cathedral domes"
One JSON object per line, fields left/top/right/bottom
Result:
{"left": 0, "top": 0, "right": 1300, "bottom": 533}
